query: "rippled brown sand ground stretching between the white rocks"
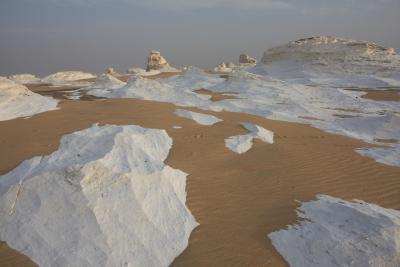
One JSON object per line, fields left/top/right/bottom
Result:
{"left": 0, "top": 87, "right": 400, "bottom": 267}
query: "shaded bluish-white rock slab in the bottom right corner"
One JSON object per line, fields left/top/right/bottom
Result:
{"left": 268, "top": 195, "right": 400, "bottom": 267}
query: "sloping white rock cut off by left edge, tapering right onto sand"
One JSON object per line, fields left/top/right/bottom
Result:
{"left": 0, "top": 78, "right": 58, "bottom": 121}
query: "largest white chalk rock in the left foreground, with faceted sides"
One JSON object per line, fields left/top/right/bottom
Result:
{"left": 0, "top": 125, "right": 197, "bottom": 267}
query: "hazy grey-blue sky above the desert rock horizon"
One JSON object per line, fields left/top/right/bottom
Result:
{"left": 0, "top": 0, "right": 400, "bottom": 75}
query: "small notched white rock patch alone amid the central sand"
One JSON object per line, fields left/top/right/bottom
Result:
{"left": 225, "top": 122, "right": 274, "bottom": 154}
